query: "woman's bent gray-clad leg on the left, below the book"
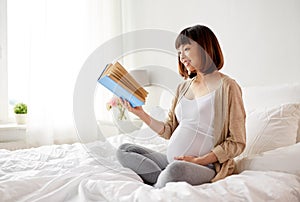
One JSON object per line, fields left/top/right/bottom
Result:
{"left": 117, "top": 143, "right": 168, "bottom": 185}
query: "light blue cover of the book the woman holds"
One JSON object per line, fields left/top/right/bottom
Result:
{"left": 98, "top": 65, "right": 145, "bottom": 107}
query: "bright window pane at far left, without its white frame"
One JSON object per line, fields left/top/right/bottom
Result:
{"left": 7, "top": 1, "right": 30, "bottom": 118}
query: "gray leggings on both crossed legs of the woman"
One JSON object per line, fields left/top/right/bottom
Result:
{"left": 117, "top": 143, "right": 216, "bottom": 188}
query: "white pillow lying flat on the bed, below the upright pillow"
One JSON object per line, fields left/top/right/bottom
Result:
{"left": 236, "top": 143, "right": 300, "bottom": 176}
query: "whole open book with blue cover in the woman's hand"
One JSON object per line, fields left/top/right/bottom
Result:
{"left": 98, "top": 62, "right": 148, "bottom": 107}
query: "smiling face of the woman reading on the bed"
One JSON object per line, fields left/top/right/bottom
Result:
{"left": 177, "top": 40, "right": 201, "bottom": 73}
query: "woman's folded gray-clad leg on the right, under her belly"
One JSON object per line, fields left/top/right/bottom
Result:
{"left": 154, "top": 161, "right": 216, "bottom": 188}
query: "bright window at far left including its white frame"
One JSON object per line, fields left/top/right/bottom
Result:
{"left": 0, "top": 0, "right": 30, "bottom": 123}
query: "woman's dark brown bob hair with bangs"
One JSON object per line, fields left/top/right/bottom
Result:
{"left": 175, "top": 25, "right": 224, "bottom": 79}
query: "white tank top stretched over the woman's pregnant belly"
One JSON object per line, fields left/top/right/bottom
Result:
{"left": 167, "top": 91, "right": 215, "bottom": 163}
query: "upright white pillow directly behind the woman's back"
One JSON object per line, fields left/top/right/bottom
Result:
{"left": 237, "top": 104, "right": 300, "bottom": 159}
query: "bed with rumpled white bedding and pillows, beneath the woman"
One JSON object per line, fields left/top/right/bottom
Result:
{"left": 0, "top": 84, "right": 300, "bottom": 202}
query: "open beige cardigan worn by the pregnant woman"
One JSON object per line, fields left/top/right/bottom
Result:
{"left": 159, "top": 73, "right": 246, "bottom": 182}
